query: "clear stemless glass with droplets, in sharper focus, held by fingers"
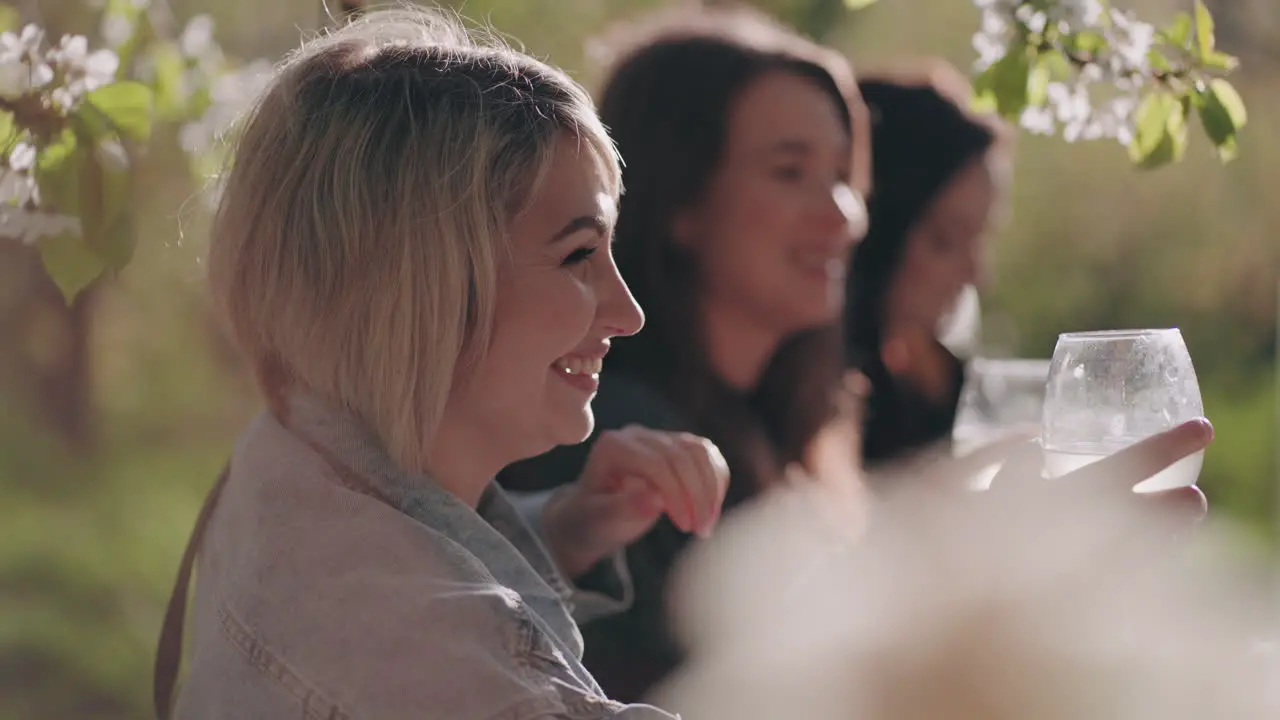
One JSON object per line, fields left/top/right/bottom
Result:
{"left": 1041, "top": 328, "right": 1204, "bottom": 492}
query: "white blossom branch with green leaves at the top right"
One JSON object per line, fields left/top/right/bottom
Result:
{"left": 974, "top": 0, "right": 1247, "bottom": 167}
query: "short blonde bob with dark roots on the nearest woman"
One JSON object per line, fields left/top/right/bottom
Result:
{"left": 209, "top": 9, "right": 621, "bottom": 469}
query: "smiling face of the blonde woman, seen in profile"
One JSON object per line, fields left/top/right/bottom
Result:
{"left": 443, "top": 136, "right": 644, "bottom": 461}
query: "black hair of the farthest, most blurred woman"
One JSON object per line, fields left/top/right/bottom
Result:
{"left": 845, "top": 68, "right": 1005, "bottom": 368}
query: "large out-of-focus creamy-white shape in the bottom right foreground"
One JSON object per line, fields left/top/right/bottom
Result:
{"left": 654, "top": 468, "right": 1280, "bottom": 720}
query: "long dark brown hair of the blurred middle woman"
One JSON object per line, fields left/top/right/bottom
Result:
{"left": 600, "top": 9, "right": 864, "bottom": 497}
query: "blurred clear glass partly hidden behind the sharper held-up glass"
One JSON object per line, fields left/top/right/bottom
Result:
{"left": 951, "top": 357, "right": 1050, "bottom": 489}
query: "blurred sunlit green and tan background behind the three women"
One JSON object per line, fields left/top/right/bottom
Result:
{"left": 0, "top": 0, "right": 1280, "bottom": 719}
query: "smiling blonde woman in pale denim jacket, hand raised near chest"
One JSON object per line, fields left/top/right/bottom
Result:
{"left": 156, "top": 12, "right": 727, "bottom": 720}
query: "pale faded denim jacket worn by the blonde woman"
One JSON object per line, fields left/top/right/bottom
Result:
{"left": 174, "top": 401, "right": 675, "bottom": 720}
